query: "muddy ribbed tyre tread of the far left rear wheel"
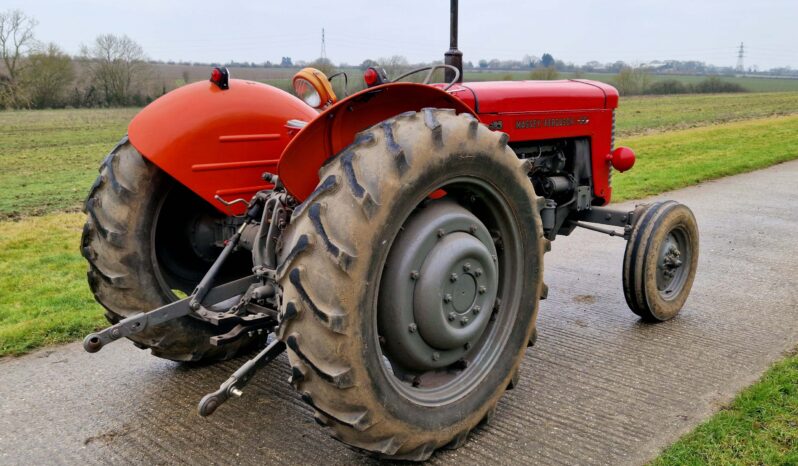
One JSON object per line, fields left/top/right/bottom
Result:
{"left": 81, "top": 137, "right": 252, "bottom": 361}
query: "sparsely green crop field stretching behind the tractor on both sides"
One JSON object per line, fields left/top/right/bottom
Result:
{"left": 0, "top": 92, "right": 798, "bottom": 220}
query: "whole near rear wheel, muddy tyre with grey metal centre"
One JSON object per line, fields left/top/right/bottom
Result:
{"left": 278, "top": 109, "right": 548, "bottom": 460}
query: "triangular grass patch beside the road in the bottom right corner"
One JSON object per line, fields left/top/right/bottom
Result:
{"left": 651, "top": 353, "right": 798, "bottom": 466}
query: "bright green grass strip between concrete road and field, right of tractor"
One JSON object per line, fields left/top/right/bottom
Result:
{"left": 612, "top": 115, "right": 798, "bottom": 201}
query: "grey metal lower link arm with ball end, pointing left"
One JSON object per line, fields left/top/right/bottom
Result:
{"left": 83, "top": 275, "right": 257, "bottom": 353}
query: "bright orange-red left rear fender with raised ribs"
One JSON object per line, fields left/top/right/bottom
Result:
{"left": 128, "top": 79, "right": 318, "bottom": 215}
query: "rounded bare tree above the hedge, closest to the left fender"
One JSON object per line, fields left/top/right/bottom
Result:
{"left": 81, "top": 34, "right": 149, "bottom": 105}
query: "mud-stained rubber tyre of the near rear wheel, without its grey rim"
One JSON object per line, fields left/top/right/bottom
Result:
{"left": 278, "top": 109, "right": 548, "bottom": 460}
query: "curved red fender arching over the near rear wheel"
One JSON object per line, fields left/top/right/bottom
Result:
{"left": 277, "top": 83, "right": 476, "bottom": 200}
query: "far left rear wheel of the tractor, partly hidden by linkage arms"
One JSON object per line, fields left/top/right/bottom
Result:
{"left": 81, "top": 138, "right": 260, "bottom": 361}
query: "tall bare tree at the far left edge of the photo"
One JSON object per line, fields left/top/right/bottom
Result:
{"left": 0, "top": 10, "right": 36, "bottom": 107}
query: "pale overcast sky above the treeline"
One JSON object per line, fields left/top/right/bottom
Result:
{"left": 6, "top": 0, "right": 798, "bottom": 70}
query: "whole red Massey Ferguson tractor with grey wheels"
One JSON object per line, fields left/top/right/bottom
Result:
{"left": 81, "top": 0, "right": 698, "bottom": 460}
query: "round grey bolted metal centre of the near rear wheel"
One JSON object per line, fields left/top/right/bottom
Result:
{"left": 378, "top": 201, "right": 498, "bottom": 371}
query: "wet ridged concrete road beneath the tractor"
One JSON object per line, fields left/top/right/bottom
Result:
{"left": 0, "top": 161, "right": 798, "bottom": 465}
